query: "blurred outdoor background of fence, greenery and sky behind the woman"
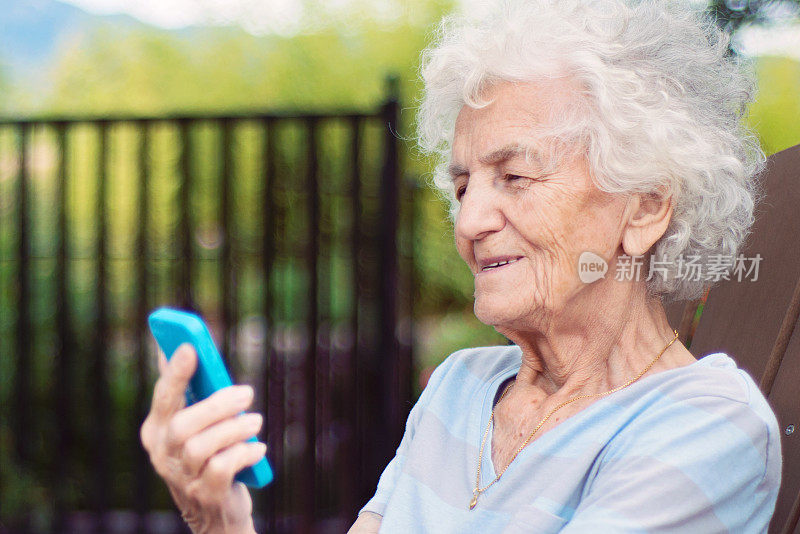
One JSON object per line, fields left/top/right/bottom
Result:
{"left": 0, "top": 0, "right": 800, "bottom": 532}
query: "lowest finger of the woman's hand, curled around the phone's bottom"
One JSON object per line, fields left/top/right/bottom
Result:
{"left": 187, "top": 442, "right": 267, "bottom": 502}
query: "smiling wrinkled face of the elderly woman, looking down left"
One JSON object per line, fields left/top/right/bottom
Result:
{"left": 450, "top": 80, "right": 626, "bottom": 330}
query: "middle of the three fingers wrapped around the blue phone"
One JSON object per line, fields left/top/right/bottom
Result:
{"left": 182, "top": 413, "right": 264, "bottom": 478}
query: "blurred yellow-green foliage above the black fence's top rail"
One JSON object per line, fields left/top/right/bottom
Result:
{"left": 42, "top": 1, "right": 447, "bottom": 114}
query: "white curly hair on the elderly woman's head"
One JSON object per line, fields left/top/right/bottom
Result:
{"left": 417, "top": 0, "right": 766, "bottom": 301}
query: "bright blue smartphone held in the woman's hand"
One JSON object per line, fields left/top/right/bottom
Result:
{"left": 148, "top": 308, "right": 272, "bottom": 488}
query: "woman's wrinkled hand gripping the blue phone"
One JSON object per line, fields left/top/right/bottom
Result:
{"left": 140, "top": 344, "right": 266, "bottom": 533}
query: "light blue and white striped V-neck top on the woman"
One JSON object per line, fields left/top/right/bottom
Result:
{"left": 361, "top": 346, "right": 781, "bottom": 534}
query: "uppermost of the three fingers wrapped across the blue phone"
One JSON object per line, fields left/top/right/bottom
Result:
{"left": 171, "top": 386, "right": 254, "bottom": 444}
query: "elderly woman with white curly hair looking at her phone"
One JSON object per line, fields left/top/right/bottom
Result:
{"left": 142, "top": 0, "right": 781, "bottom": 534}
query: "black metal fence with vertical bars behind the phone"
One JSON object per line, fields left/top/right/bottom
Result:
{"left": 0, "top": 77, "right": 413, "bottom": 533}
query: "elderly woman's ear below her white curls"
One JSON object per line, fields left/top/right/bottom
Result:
{"left": 622, "top": 193, "right": 672, "bottom": 256}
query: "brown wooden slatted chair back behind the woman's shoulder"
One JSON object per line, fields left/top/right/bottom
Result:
{"left": 667, "top": 145, "right": 800, "bottom": 534}
